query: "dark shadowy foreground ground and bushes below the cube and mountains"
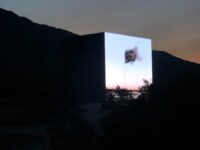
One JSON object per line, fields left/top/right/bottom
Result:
{"left": 0, "top": 72, "right": 200, "bottom": 150}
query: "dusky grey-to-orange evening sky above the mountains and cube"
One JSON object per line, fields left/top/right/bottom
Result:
{"left": 0, "top": 0, "right": 200, "bottom": 63}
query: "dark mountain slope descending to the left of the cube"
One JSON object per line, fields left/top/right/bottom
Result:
{"left": 0, "top": 8, "right": 77, "bottom": 122}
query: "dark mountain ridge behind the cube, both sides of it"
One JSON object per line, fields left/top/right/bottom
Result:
{"left": 0, "top": 8, "right": 200, "bottom": 124}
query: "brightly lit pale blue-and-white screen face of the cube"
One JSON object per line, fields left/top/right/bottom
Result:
{"left": 105, "top": 33, "right": 152, "bottom": 90}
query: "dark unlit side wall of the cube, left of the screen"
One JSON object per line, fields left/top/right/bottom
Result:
{"left": 63, "top": 33, "right": 105, "bottom": 105}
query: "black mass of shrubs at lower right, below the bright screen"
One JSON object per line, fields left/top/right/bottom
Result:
{"left": 102, "top": 72, "right": 200, "bottom": 149}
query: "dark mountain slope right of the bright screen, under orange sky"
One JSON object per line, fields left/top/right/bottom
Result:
{"left": 152, "top": 50, "right": 200, "bottom": 84}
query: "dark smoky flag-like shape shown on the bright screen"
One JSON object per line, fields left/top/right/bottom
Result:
{"left": 124, "top": 47, "right": 138, "bottom": 63}
